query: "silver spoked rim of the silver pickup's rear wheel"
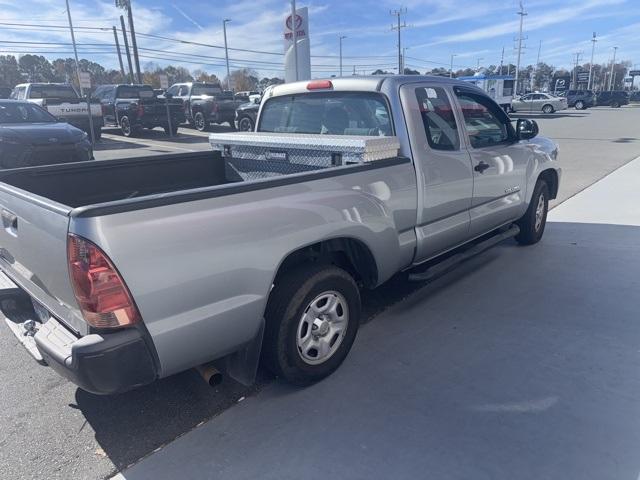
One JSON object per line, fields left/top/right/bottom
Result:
{"left": 296, "top": 291, "right": 349, "bottom": 365}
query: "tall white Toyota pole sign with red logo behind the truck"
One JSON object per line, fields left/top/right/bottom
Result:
{"left": 283, "top": 7, "right": 311, "bottom": 82}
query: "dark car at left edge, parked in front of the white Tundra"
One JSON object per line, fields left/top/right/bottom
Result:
{"left": 0, "top": 100, "right": 93, "bottom": 169}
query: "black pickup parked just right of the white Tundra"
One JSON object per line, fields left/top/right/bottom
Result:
{"left": 92, "top": 84, "right": 184, "bottom": 137}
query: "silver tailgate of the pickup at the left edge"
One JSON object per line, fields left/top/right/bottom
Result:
{"left": 0, "top": 183, "right": 88, "bottom": 335}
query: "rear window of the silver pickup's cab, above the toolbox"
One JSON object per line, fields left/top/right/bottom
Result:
{"left": 258, "top": 92, "right": 393, "bottom": 136}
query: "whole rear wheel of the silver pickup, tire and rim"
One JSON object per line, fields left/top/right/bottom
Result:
{"left": 263, "top": 263, "right": 360, "bottom": 385}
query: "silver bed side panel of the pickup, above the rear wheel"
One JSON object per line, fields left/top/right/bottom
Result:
{"left": 70, "top": 162, "right": 416, "bottom": 376}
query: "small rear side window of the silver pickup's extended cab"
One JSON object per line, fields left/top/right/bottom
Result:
{"left": 416, "top": 87, "right": 460, "bottom": 150}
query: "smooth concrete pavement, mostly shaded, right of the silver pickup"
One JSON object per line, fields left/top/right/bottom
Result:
{"left": 116, "top": 159, "right": 640, "bottom": 480}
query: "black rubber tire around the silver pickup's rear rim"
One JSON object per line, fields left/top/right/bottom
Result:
{"left": 262, "top": 263, "right": 360, "bottom": 386}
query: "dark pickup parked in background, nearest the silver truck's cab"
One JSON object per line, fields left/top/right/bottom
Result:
{"left": 167, "top": 82, "right": 237, "bottom": 132}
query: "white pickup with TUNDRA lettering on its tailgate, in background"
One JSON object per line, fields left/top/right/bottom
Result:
{"left": 11, "top": 83, "right": 103, "bottom": 140}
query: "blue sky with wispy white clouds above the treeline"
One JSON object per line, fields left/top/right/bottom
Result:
{"left": 0, "top": 0, "right": 640, "bottom": 77}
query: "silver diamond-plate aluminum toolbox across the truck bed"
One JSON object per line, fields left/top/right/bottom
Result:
{"left": 209, "top": 132, "right": 400, "bottom": 180}
